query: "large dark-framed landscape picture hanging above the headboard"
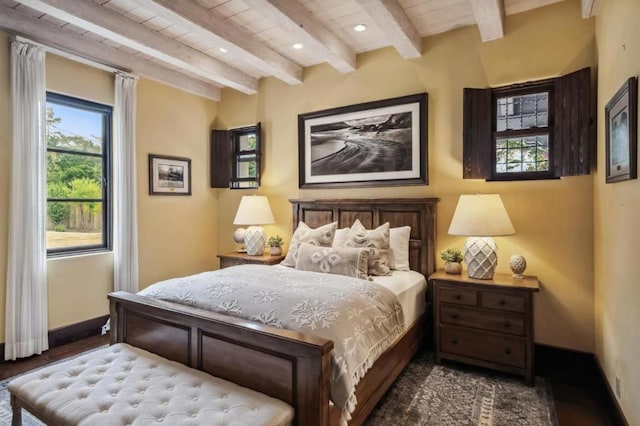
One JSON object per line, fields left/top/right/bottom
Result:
{"left": 298, "top": 93, "right": 428, "bottom": 188}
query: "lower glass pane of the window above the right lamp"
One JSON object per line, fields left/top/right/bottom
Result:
{"left": 496, "top": 134, "right": 549, "bottom": 173}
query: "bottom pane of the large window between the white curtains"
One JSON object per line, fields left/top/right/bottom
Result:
{"left": 47, "top": 201, "right": 105, "bottom": 249}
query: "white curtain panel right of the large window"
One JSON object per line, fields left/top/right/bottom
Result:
{"left": 113, "top": 73, "right": 138, "bottom": 293}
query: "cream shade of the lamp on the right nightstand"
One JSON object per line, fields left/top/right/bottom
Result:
{"left": 449, "top": 194, "right": 516, "bottom": 237}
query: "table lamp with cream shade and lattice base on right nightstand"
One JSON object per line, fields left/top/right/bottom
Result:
{"left": 449, "top": 194, "right": 516, "bottom": 280}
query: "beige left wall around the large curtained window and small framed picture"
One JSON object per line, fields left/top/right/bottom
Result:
{"left": 0, "top": 32, "right": 217, "bottom": 342}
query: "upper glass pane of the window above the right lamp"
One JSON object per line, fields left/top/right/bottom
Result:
{"left": 496, "top": 92, "right": 549, "bottom": 132}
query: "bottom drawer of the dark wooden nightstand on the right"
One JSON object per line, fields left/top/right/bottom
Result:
{"left": 439, "top": 327, "right": 527, "bottom": 368}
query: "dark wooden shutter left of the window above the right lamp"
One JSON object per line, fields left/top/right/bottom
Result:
{"left": 462, "top": 89, "right": 493, "bottom": 179}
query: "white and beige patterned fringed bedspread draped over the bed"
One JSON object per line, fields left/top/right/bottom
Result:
{"left": 139, "top": 265, "right": 404, "bottom": 424}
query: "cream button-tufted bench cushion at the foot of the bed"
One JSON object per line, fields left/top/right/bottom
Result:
{"left": 9, "top": 343, "right": 293, "bottom": 426}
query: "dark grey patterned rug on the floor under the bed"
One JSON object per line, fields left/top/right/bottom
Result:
{"left": 0, "top": 353, "right": 558, "bottom": 426}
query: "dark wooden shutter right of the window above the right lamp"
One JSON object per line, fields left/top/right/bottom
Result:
{"left": 553, "top": 68, "right": 594, "bottom": 177}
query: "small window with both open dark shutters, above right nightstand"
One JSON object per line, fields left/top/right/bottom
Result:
{"left": 463, "top": 68, "right": 594, "bottom": 180}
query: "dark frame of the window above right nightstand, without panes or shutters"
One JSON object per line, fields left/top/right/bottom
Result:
{"left": 489, "top": 79, "right": 557, "bottom": 181}
